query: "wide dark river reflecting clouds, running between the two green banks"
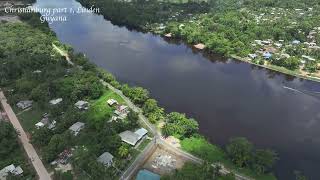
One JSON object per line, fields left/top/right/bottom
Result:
{"left": 35, "top": 0, "right": 320, "bottom": 179}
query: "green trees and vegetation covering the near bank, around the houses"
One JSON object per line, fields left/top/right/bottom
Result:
{"left": 0, "top": 6, "right": 284, "bottom": 179}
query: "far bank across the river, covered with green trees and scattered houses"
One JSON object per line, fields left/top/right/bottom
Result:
{"left": 79, "top": 0, "right": 320, "bottom": 77}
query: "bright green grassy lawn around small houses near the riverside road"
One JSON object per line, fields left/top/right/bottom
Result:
{"left": 87, "top": 90, "right": 125, "bottom": 121}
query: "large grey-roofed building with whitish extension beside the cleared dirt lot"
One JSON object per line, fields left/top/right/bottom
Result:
{"left": 119, "top": 128, "right": 148, "bottom": 146}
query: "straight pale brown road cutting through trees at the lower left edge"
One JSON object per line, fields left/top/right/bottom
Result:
{"left": 0, "top": 91, "right": 51, "bottom": 180}
